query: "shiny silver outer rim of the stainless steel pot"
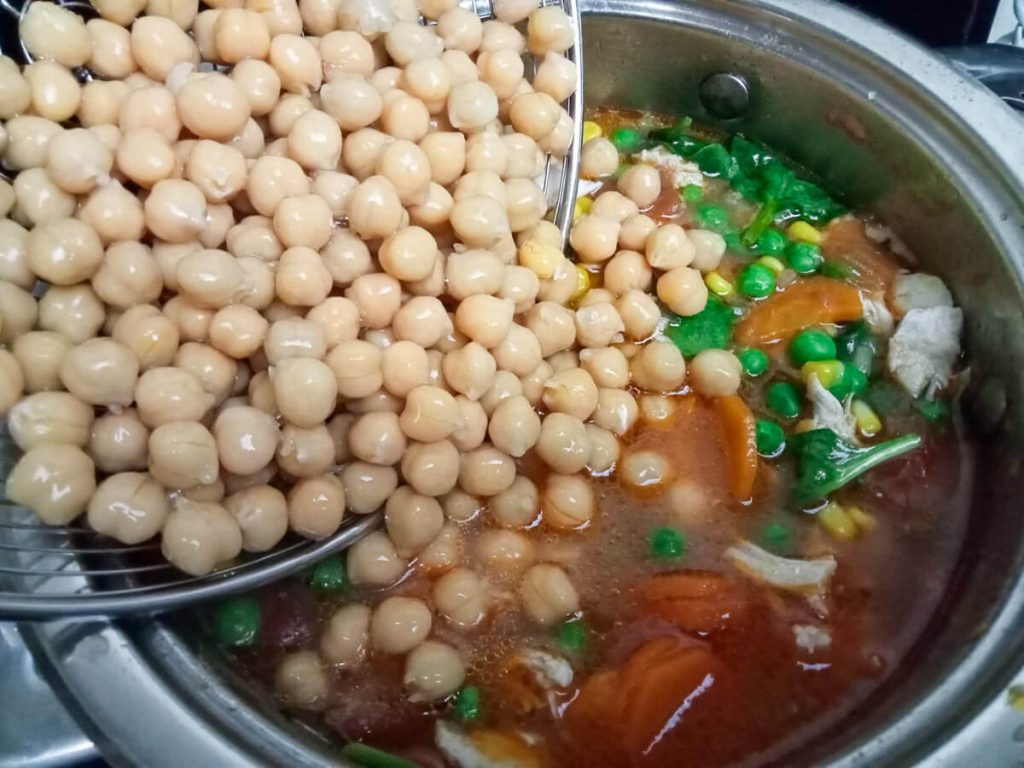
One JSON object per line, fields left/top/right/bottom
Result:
{"left": 23, "top": 0, "right": 1024, "bottom": 768}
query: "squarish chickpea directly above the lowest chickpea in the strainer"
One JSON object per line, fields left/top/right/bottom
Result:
{"left": 148, "top": 422, "right": 219, "bottom": 489}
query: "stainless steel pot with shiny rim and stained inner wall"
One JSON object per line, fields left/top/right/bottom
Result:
{"left": 18, "top": 0, "right": 1024, "bottom": 768}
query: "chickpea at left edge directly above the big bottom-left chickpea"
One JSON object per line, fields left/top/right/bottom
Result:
{"left": 2, "top": 393, "right": 92, "bottom": 451}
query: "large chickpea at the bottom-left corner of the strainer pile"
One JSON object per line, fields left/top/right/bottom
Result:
{"left": 6, "top": 443, "right": 96, "bottom": 525}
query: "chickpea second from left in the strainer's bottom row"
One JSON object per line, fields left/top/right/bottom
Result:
{"left": 87, "top": 472, "right": 169, "bottom": 545}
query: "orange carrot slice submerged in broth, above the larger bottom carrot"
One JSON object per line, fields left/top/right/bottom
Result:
{"left": 640, "top": 570, "right": 746, "bottom": 633}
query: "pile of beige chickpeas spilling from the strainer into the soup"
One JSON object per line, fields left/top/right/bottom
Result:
{"left": 0, "top": 0, "right": 738, "bottom": 707}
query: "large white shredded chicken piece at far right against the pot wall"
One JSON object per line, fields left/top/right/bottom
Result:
{"left": 888, "top": 306, "right": 964, "bottom": 397}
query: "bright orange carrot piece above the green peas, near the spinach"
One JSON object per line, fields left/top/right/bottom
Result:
{"left": 736, "top": 278, "right": 864, "bottom": 345}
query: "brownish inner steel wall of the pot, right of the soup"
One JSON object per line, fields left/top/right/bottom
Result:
{"left": 584, "top": 2, "right": 1024, "bottom": 765}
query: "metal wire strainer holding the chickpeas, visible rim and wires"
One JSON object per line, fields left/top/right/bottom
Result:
{"left": 0, "top": 0, "right": 583, "bottom": 620}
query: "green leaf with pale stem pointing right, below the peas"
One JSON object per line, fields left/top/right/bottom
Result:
{"left": 790, "top": 429, "right": 921, "bottom": 507}
